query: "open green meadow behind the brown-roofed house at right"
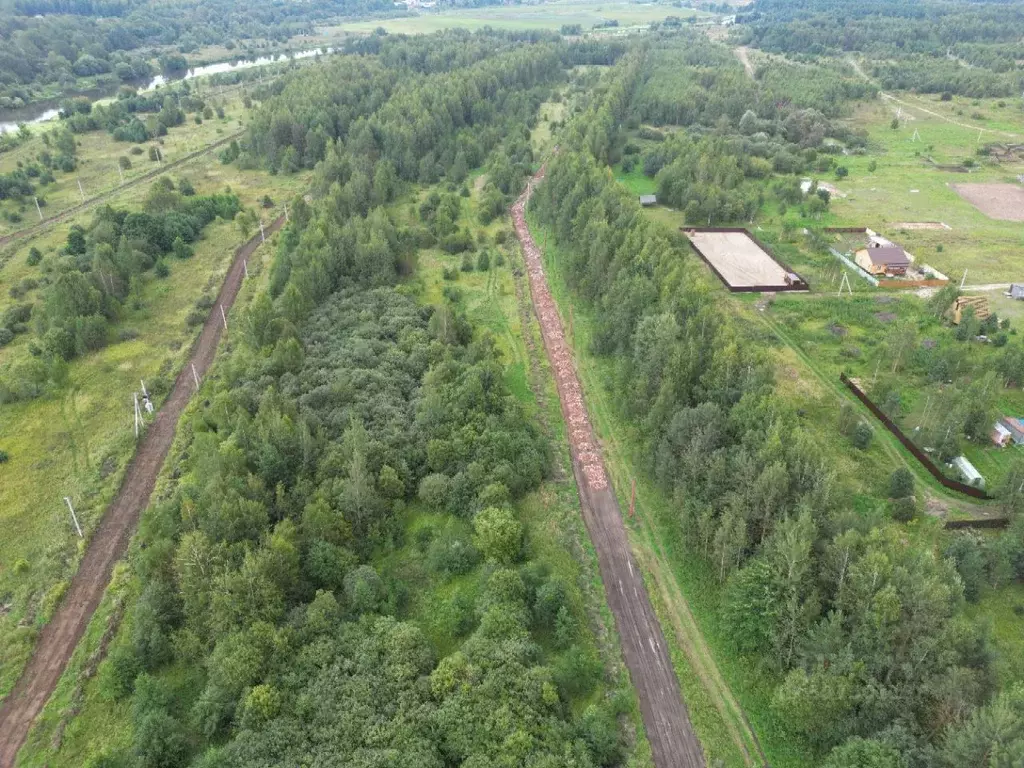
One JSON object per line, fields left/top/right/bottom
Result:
{"left": 794, "top": 94, "right": 1024, "bottom": 285}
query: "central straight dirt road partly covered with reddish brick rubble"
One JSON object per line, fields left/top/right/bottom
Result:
{"left": 512, "top": 169, "right": 705, "bottom": 768}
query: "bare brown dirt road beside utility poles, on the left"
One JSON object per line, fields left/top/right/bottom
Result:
{"left": 0, "top": 211, "right": 285, "bottom": 768}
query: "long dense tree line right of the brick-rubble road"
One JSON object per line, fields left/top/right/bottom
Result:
{"left": 531, "top": 55, "right": 1021, "bottom": 768}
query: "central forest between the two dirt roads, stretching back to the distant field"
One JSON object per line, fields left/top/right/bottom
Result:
{"left": 88, "top": 36, "right": 643, "bottom": 768}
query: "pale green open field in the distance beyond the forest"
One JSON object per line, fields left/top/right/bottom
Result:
{"left": 324, "top": 0, "right": 705, "bottom": 37}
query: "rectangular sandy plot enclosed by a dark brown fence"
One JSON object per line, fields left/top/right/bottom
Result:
{"left": 683, "top": 227, "right": 808, "bottom": 291}
